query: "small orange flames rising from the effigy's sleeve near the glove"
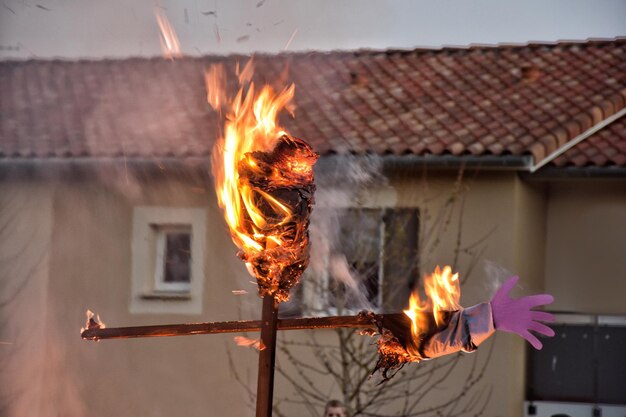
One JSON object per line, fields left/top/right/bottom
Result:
{"left": 404, "top": 266, "right": 461, "bottom": 337}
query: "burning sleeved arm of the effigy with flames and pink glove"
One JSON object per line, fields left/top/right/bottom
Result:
{"left": 376, "top": 267, "right": 554, "bottom": 378}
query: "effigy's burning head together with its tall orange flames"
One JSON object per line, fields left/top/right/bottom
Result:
{"left": 205, "top": 61, "right": 317, "bottom": 299}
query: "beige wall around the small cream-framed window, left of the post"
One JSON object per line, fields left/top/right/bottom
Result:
{"left": 50, "top": 171, "right": 259, "bottom": 416}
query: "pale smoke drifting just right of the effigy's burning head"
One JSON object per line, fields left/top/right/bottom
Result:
{"left": 288, "top": 154, "right": 386, "bottom": 315}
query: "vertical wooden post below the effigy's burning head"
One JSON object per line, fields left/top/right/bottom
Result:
{"left": 256, "top": 295, "right": 278, "bottom": 417}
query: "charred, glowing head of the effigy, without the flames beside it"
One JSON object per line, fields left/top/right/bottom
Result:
{"left": 239, "top": 134, "right": 317, "bottom": 301}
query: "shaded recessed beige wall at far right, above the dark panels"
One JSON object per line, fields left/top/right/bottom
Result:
{"left": 545, "top": 180, "right": 626, "bottom": 315}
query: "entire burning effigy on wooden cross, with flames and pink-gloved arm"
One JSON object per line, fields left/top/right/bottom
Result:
{"left": 81, "top": 13, "right": 554, "bottom": 417}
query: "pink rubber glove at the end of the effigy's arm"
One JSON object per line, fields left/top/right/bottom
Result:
{"left": 491, "top": 276, "right": 554, "bottom": 350}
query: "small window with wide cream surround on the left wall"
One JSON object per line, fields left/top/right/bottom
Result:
{"left": 130, "top": 207, "right": 206, "bottom": 314}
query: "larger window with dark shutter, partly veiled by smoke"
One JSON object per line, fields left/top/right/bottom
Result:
{"left": 294, "top": 208, "right": 419, "bottom": 315}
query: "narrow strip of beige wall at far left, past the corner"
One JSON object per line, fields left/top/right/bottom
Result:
{"left": 0, "top": 179, "right": 56, "bottom": 416}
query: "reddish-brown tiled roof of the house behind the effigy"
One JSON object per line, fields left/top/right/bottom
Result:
{"left": 0, "top": 38, "right": 626, "bottom": 166}
